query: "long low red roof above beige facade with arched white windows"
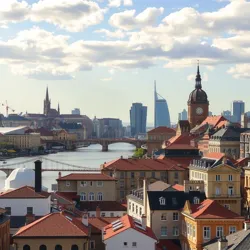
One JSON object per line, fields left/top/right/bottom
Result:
{"left": 57, "top": 173, "right": 116, "bottom": 181}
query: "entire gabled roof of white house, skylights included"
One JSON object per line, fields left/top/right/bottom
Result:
{"left": 103, "top": 215, "right": 157, "bottom": 241}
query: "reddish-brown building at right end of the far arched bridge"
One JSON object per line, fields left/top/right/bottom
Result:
{"left": 147, "top": 127, "right": 176, "bottom": 156}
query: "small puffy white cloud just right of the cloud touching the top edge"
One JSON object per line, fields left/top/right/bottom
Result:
{"left": 109, "top": 8, "right": 164, "bottom": 30}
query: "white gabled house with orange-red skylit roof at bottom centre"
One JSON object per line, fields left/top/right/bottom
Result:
{"left": 103, "top": 215, "right": 157, "bottom": 250}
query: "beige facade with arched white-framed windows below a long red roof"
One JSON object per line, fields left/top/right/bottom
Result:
{"left": 57, "top": 180, "right": 116, "bottom": 201}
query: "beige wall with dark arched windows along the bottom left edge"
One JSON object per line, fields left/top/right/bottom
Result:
{"left": 14, "top": 237, "right": 89, "bottom": 250}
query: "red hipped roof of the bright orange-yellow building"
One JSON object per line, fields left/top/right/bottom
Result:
{"left": 190, "top": 199, "right": 244, "bottom": 220}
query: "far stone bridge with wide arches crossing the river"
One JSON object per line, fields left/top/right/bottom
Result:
{"left": 43, "top": 138, "right": 147, "bottom": 152}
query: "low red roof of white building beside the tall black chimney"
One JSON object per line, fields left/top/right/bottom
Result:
{"left": 0, "top": 186, "right": 50, "bottom": 199}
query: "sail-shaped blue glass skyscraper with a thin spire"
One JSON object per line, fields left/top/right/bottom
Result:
{"left": 154, "top": 81, "right": 171, "bottom": 128}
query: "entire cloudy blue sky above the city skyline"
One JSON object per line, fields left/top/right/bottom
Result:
{"left": 0, "top": 0, "right": 250, "bottom": 123}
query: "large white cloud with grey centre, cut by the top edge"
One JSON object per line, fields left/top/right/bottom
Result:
{"left": 30, "top": 0, "right": 106, "bottom": 32}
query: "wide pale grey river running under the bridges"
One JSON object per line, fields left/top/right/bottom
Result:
{"left": 0, "top": 143, "right": 135, "bottom": 190}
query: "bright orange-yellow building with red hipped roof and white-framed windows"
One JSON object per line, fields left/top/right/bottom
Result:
{"left": 180, "top": 199, "right": 244, "bottom": 250}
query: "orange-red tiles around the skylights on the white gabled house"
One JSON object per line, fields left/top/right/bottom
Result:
{"left": 104, "top": 215, "right": 157, "bottom": 241}
